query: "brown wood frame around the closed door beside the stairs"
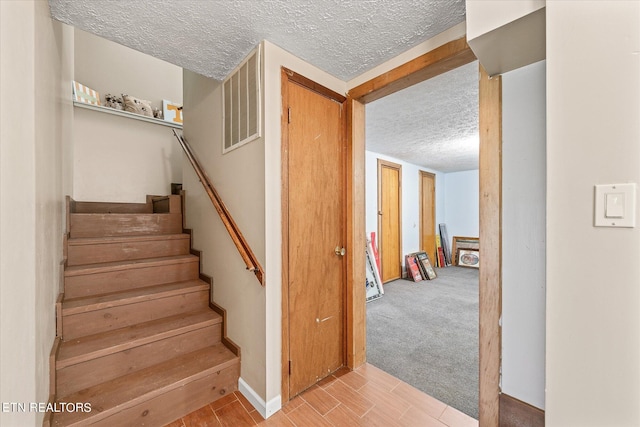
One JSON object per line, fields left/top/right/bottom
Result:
{"left": 280, "top": 67, "right": 348, "bottom": 403}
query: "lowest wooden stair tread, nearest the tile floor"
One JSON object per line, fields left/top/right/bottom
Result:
{"left": 53, "top": 344, "right": 239, "bottom": 426}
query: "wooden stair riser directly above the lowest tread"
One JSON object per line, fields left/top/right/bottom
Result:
{"left": 56, "top": 323, "right": 221, "bottom": 396}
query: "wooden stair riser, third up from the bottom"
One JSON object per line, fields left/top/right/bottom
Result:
{"left": 62, "top": 290, "right": 209, "bottom": 341}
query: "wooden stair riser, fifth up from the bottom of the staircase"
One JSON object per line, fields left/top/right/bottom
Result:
{"left": 67, "top": 238, "right": 190, "bottom": 267}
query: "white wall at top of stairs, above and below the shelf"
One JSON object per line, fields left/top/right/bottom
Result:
{"left": 69, "top": 29, "right": 182, "bottom": 202}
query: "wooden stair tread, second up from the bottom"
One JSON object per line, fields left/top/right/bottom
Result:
{"left": 56, "top": 309, "right": 222, "bottom": 369}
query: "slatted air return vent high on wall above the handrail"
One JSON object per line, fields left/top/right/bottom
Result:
{"left": 222, "top": 46, "right": 262, "bottom": 153}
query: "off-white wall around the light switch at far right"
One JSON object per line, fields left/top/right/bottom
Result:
{"left": 546, "top": 1, "right": 640, "bottom": 427}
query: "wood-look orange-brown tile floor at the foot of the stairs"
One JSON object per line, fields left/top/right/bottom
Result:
{"left": 167, "top": 364, "right": 478, "bottom": 427}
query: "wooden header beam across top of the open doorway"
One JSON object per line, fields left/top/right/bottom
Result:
{"left": 349, "top": 37, "right": 476, "bottom": 104}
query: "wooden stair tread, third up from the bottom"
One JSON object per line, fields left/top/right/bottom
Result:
{"left": 62, "top": 280, "right": 209, "bottom": 316}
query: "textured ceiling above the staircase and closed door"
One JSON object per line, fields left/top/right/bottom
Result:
{"left": 49, "top": 0, "right": 465, "bottom": 80}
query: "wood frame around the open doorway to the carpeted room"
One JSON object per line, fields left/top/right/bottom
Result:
{"left": 347, "top": 37, "right": 502, "bottom": 427}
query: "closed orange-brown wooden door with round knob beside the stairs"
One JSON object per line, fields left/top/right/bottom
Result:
{"left": 283, "top": 72, "right": 346, "bottom": 396}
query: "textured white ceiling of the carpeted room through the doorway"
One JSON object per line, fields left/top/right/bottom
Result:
{"left": 366, "top": 61, "right": 479, "bottom": 172}
